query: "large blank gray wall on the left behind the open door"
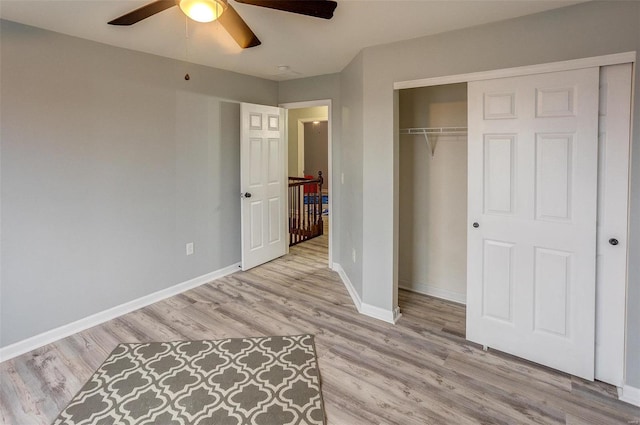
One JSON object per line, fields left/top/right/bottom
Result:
{"left": 0, "top": 21, "right": 278, "bottom": 347}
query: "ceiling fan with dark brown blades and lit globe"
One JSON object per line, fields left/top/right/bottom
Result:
{"left": 109, "top": 0, "right": 338, "bottom": 49}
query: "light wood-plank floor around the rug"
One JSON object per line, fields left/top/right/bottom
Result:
{"left": 0, "top": 232, "right": 640, "bottom": 425}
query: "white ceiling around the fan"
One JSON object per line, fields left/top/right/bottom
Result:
{"left": 0, "top": 0, "right": 580, "bottom": 80}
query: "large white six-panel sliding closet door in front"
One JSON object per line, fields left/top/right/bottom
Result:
{"left": 467, "top": 68, "right": 599, "bottom": 380}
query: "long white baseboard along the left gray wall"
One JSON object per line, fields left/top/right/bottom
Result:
{"left": 0, "top": 263, "right": 240, "bottom": 362}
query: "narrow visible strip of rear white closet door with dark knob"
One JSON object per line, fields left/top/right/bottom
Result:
{"left": 596, "top": 63, "right": 632, "bottom": 387}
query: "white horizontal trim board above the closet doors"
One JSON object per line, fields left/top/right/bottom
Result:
{"left": 393, "top": 52, "right": 636, "bottom": 90}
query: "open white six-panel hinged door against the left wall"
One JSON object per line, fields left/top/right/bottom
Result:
{"left": 240, "top": 103, "right": 287, "bottom": 270}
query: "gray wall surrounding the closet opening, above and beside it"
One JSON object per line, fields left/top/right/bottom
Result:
{"left": 352, "top": 2, "right": 640, "bottom": 387}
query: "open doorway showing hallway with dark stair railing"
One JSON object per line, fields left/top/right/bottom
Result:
{"left": 281, "top": 100, "right": 332, "bottom": 266}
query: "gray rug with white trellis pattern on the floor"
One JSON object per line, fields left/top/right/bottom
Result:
{"left": 53, "top": 335, "right": 325, "bottom": 425}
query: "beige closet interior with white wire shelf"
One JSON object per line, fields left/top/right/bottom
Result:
{"left": 398, "top": 83, "right": 467, "bottom": 303}
